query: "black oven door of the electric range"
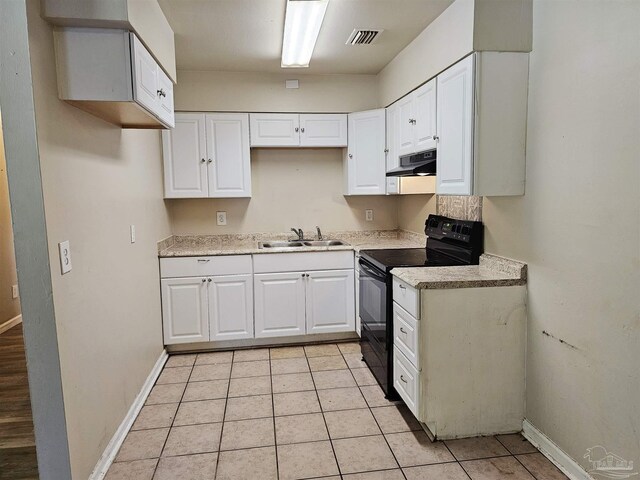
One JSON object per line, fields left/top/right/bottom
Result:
{"left": 359, "top": 258, "right": 388, "bottom": 348}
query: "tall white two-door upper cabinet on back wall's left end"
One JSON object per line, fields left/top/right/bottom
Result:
{"left": 162, "top": 113, "right": 251, "bottom": 198}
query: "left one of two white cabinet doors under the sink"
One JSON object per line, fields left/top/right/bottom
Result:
{"left": 253, "top": 272, "right": 306, "bottom": 338}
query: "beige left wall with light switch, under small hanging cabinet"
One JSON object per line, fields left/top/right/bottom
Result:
{"left": 28, "top": 0, "right": 170, "bottom": 479}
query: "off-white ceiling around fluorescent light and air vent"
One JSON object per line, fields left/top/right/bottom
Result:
{"left": 159, "top": 0, "right": 453, "bottom": 74}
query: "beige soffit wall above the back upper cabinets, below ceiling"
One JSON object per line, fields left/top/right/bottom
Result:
{"left": 174, "top": 70, "right": 378, "bottom": 112}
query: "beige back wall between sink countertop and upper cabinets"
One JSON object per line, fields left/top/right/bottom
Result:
{"left": 166, "top": 148, "right": 398, "bottom": 235}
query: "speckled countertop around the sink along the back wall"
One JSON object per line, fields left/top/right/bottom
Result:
{"left": 158, "top": 230, "right": 427, "bottom": 257}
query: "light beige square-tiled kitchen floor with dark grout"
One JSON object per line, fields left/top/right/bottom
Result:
{"left": 106, "top": 343, "right": 566, "bottom": 480}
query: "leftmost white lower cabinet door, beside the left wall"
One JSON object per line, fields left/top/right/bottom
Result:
{"left": 160, "top": 277, "right": 209, "bottom": 345}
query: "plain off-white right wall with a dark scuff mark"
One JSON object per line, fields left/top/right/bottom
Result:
{"left": 483, "top": 0, "right": 640, "bottom": 468}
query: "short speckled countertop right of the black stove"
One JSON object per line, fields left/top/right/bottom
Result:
{"left": 391, "top": 253, "right": 527, "bottom": 289}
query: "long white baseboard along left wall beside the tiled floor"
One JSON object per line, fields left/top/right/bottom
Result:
{"left": 89, "top": 350, "right": 169, "bottom": 480}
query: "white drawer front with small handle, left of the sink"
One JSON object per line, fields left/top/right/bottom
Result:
{"left": 160, "top": 255, "right": 252, "bottom": 278}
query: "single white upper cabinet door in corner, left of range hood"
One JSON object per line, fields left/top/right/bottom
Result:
{"left": 345, "top": 108, "right": 386, "bottom": 195}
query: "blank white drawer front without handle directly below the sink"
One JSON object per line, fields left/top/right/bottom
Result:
{"left": 253, "top": 250, "right": 353, "bottom": 273}
